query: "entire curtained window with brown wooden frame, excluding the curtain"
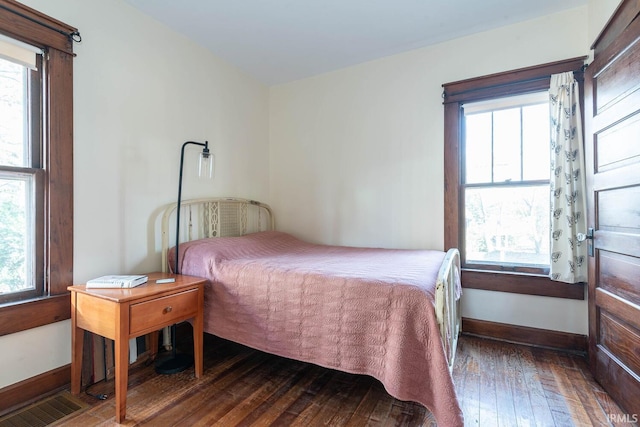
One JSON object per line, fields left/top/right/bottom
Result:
{"left": 443, "top": 57, "right": 586, "bottom": 299}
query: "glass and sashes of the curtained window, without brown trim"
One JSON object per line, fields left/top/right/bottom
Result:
{"left": 461, "top": 92, "right": 550, "bottom": 273}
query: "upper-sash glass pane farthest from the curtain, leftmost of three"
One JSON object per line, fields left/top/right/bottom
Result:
{"left": 465, "top": 113, "right": 492, "bottom": 184}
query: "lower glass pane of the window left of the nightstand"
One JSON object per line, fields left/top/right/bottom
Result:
{"left": 0, "top": 173, "right": 35, "bottom": 295}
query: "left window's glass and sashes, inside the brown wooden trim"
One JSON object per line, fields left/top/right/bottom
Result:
{"left": 0, "top": 38, "right": 44, "bottom": 302}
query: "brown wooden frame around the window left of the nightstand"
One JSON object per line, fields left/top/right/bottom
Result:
{"left": 0, "top": 0, "right": 78, "bottom": 336}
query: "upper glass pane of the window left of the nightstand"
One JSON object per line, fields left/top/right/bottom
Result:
{"left": 0, "top": 58, "right": 29, "bottom": 167}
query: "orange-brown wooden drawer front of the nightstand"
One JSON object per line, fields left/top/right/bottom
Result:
{"left": 129, "top": 289, "right": 198, "bottom": 335}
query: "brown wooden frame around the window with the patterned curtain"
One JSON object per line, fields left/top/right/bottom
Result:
{"left": 442, "top": 57, "right": 586, "bottom": 300}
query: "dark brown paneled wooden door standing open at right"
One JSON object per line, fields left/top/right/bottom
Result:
{"left": 585, "top": 0, "right": 640, "bottom": 421}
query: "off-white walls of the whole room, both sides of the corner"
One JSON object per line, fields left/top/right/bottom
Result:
{"left": 0, "top": 0, "right": 617, "bottom": 387}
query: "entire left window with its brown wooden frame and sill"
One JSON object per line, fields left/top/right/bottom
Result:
{"left": 0, "top": 0, "right": 78, "bottom": 335}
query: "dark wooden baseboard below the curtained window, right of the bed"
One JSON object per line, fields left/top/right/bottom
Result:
{"left": 462, "top": 317, "right": 588, "bottom": 354}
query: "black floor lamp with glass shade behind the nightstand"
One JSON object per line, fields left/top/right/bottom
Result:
{"left": 155, "top": 141, "right": 214, "bottom": 374}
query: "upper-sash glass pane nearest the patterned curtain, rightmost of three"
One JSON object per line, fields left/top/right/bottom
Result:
{"left": 522, "top": 103, "right": 551, "bottom": 180}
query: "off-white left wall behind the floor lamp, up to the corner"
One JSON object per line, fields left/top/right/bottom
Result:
{"left": 0, "top": 0, "right": 269, "bottom": 387}
